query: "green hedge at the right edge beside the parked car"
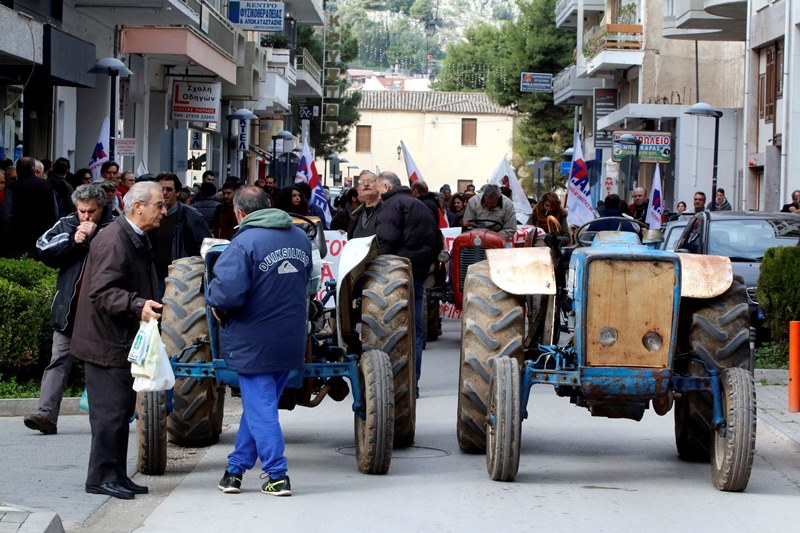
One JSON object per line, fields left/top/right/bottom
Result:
{"left": 756, "top": 246, "right": 800, "bottom": 345}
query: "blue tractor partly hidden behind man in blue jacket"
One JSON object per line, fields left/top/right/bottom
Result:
{"left": 137, "top": 220, "right": 416, "bottom": 475}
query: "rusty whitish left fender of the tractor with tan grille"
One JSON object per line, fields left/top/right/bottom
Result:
{"left": 486, "top": 247, "right": 556, "bottom": 294}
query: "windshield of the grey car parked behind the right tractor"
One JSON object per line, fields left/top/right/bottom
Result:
{"left": 708, "top": 217, "right": 800, "bottom": 261}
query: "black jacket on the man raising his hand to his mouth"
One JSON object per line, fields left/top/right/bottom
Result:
{"left": 36, "top": 207, "right": 114, "bottom": 335}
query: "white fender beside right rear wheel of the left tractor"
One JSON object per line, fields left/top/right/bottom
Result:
{"left": 336, "top": 236, "right": 380, "bottom": 346}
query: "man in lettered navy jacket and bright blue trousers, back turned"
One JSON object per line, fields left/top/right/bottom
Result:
{"left": 206, "top": 186, "right": 311, "bottom": 496}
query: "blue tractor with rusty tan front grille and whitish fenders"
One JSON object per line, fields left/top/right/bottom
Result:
{"left": 457, "top": 219, "right": 756, "bottom": 491}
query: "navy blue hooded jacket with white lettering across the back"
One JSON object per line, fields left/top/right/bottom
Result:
{"left": 206, "top": 209, "right": 311, "bottom": 374}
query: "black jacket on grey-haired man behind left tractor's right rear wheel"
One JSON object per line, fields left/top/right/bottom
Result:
{"left": 375, "top": 187, "right": 442, "bottom": 280}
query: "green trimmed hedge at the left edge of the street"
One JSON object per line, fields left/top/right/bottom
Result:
{"left": 0, "top": 259, "right": 57, "bottom": 377}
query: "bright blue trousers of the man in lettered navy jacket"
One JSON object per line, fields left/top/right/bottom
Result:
{"left": 228, "top": 370, "right": 289, "bottom": 479}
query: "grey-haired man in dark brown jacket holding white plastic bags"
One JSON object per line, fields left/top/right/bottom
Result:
{"left": 70, "top": 182, "right": 166, "bottom": 500}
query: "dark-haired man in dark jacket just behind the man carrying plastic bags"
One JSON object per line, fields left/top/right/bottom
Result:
{"left": 147, "top": 172, "right": 211, "bottom": 299}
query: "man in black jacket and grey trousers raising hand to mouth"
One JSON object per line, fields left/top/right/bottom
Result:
{"left": 24, "top": 185, "right": 114, "bottom": 435}
